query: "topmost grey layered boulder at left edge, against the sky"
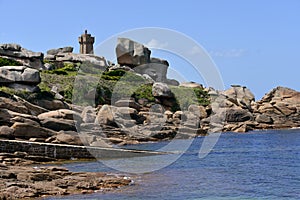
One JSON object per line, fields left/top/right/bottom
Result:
{"left": 0, "top": 44, "right": 44, "bottom": 70}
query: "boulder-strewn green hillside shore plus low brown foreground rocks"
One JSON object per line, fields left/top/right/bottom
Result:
{"left": 0, "top": 38, "right": 300, "bottom": 199}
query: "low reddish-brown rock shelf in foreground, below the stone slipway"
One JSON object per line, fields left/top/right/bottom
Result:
{"left": 0, "top": 152, "right": 132, "bottom": 200}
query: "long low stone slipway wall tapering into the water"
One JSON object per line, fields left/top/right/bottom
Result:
{"left": 0, "top": 140, "right": 162, "bottom": 159}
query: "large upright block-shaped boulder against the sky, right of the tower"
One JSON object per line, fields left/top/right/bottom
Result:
{"left": 116, "top": 38, "right": 151, "bottom": 67}
